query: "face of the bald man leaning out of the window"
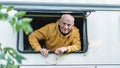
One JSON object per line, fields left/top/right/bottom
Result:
{"left": 59, "top": 18, "right": 74, "bottom": 34}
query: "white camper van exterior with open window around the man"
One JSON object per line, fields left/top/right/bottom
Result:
{"left": 0, "top": 1, "right": 120, "bottom": 68}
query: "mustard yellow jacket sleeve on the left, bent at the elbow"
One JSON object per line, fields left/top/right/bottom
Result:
{"left": 28, "top": 25, "right": 48, "bottom": 51}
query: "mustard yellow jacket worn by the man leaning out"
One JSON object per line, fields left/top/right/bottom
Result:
{"left": 29, "top": 22, "right": 81, "bottom": 52}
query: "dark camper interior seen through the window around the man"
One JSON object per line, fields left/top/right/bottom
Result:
{"left": 18, "top": 12, "right": 87, "bottom": 52}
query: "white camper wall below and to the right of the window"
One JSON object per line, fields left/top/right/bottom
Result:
{"left": 17, "top": 11, "right": 120, "bottom": 68}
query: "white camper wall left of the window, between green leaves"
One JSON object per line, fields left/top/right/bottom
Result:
{"left": 0, "top": 9, "right": 17, "bottom": 49}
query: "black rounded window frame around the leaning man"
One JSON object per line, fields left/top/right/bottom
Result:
{"left": 17, "top": 10, "right": 88, "bottom": 53}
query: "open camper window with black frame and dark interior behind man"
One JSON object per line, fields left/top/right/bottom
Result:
{"left": 17, "top": 11, "right": 88, "bottom": 53}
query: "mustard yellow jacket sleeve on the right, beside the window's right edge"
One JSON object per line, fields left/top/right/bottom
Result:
{"left": 67, "top": 29, "right": 81, "bottom": 52}
